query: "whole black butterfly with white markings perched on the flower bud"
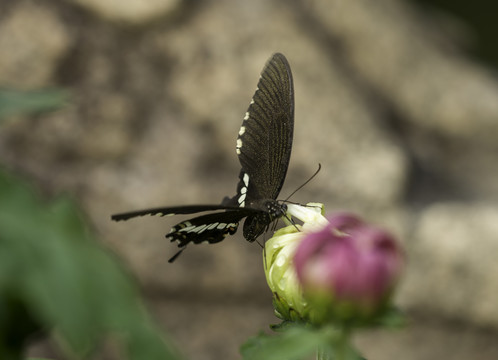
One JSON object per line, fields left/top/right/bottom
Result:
{"left": 112, "top": 53, "right": 294, "bottom": 262}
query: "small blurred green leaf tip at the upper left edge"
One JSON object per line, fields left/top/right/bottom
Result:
{"left": 0, "top": 88, "right": 68, "bottom": 120}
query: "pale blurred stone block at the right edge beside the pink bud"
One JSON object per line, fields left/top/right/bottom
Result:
{"left": 401, "top": 203, "right": 498, "bottom": 326}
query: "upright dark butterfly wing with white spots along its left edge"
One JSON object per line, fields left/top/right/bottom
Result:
{"left": 232, "top": 53, "right": 294, "bottom": 207}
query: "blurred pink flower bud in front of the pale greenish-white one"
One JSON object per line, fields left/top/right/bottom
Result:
{"left": 294, "top": 214, "right": 404, "bottom": 322}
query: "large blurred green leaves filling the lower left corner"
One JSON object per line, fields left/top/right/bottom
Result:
{"left": 0, "top": 169, "right": 183, "bottom": 360}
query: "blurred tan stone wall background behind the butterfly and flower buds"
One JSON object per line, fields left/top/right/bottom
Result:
{"left": 0, "top": 0, "right": 498, "bottom": 360}
